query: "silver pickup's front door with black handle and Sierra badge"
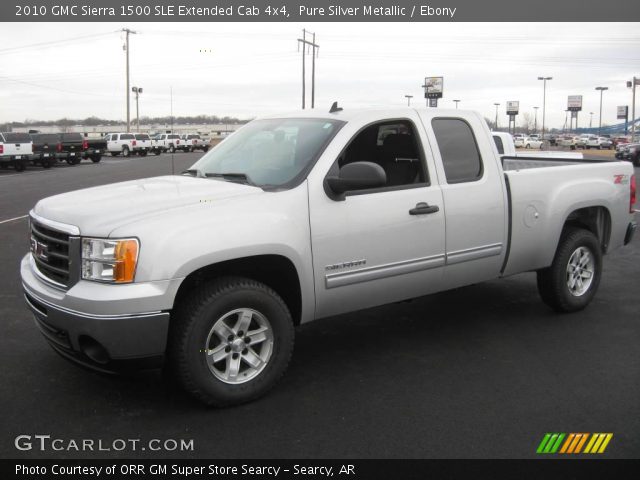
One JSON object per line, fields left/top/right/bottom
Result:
{"left": 309, "top": 114, "right": 445, "bottom": 317}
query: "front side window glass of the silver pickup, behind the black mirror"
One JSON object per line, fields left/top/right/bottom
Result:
{"left": 337, "top": 120, "right": 428, "bottom": 190}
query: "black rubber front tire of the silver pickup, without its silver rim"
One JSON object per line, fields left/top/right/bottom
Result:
{"left": 168, "top": 277, "right": 294, "bottom": 407}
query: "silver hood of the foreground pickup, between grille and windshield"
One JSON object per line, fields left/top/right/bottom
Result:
{"left": 34, "top": 175, "right": 264, "bottom": 236}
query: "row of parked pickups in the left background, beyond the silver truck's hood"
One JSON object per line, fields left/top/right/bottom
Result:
{"left": 0, "top": 132, "right": 214, "bottom": 172}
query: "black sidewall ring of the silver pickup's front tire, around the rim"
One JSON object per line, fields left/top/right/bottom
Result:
{"left": 178, "top": 285, "right": 293, "bottom": 405}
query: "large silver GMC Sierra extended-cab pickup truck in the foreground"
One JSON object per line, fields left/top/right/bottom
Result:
{"left": 21, "top": 107, "right": 636, "bottom": 406}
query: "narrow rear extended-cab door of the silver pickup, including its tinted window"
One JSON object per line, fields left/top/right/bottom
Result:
{"left": 420, "top": 111, "right": 508, "bottom": 288}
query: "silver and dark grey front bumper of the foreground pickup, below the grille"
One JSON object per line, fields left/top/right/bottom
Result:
{"left": 21, "top": 254, "right": 179, "bottom": 371}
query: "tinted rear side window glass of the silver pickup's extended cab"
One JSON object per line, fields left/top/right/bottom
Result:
{"left": 431, "top": 118, "right": 482, "bottom": 183}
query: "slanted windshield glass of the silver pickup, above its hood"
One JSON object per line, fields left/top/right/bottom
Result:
{"left": 190, "top": 118, "right": 344, "bottom": 187}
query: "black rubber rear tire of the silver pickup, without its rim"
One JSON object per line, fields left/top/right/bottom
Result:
{"left": 537, "top": 227, "right": 602, "bottom": 312}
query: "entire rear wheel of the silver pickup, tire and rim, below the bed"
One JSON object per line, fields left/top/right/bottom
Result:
{"left": 537, "top": 227, "right": 602, "bottom": 312}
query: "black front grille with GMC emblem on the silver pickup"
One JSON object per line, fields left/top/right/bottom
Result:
{"left": 31, "top": 218, "right": 69, "bottom": 286}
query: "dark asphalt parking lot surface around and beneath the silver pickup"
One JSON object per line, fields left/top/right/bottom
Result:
{"left": 0, "top": 153, "right": 640, "bottom": 458}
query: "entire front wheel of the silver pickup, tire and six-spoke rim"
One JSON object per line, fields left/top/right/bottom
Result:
{"left": 168, "top": 277, "right": 294, "bottom": 407}
